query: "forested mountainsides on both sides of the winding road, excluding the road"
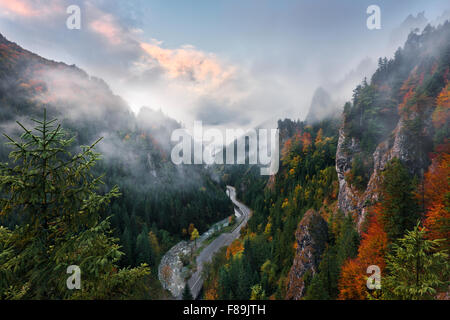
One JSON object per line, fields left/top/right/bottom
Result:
{"left": 0, "top": 22, "right": 450, "bottom": 300}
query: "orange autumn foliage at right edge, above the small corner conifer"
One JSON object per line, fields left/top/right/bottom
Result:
{"left": 424, "top": 152, "right": 450, "bottom": 249}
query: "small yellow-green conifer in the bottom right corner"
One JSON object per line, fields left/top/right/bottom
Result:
{"left": 381, "top": 224, "right": 450, "bottom": 300}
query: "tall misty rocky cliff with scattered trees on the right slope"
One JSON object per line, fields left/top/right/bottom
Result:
{"left": 336, "top": 23, "right": 450, "bottom": 228}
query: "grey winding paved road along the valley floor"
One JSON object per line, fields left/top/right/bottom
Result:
{"left": 188, "top": 186, "right": 251, "bottom": 299}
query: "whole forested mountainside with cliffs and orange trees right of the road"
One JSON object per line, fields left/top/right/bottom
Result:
{"left": 204, "top": 22, "right": 450, "bottom": 300}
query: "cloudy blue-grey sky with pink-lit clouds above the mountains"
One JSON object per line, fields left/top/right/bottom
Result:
{"left": 0, "top": 0, "right": 450, "bottom": 128}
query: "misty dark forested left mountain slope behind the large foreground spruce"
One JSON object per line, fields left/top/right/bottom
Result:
{"left": 0, "top": 31, "right": 233, "bottom": 296}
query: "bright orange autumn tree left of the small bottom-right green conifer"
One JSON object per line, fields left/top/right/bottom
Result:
{"left": 338, "top": 205, "right": 388, "bottom": 300}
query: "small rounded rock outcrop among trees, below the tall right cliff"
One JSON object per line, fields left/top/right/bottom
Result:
{"left": 286, "top": 209, "right": 328, "bottom": 300}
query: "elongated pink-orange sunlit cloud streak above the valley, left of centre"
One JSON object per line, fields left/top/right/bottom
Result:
{"left": 87, "top": 3, "right": 236, "bottom": 93}
